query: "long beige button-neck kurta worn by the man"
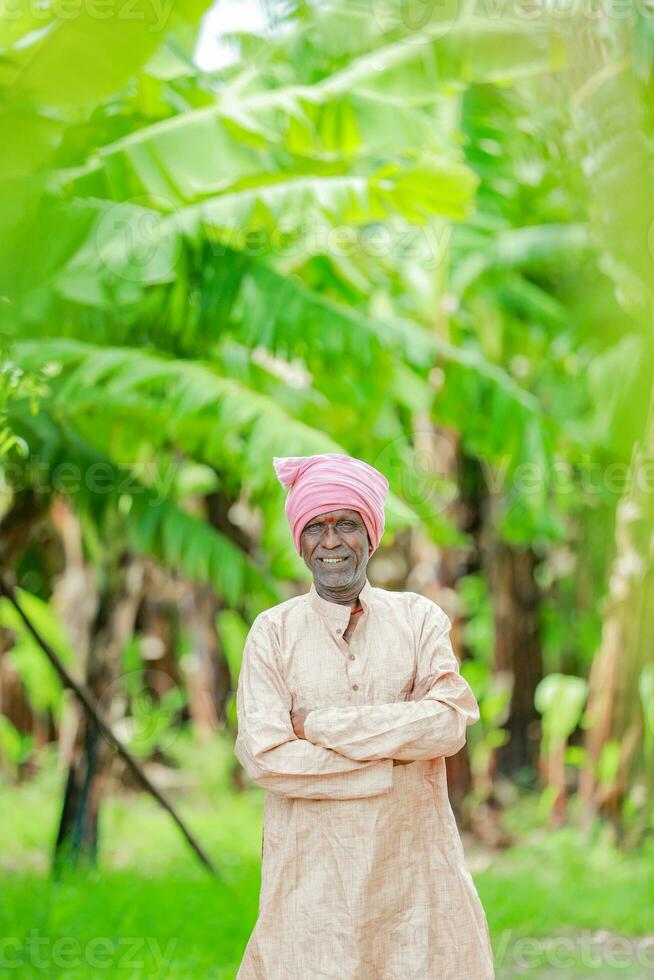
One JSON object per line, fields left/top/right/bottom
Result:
{"left": 236, "top": 581, "right": 494, "bottom": 980}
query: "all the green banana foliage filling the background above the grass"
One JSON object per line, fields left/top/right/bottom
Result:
{"left": 0, "top": 0, "right": 654, "bottom": 840}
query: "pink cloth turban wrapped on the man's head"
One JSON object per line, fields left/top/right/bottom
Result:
{"left": 273, "top": 453, "right": 388, "bottom": 556}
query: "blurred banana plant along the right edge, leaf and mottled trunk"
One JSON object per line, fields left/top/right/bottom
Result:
{"left": 573, "top": 11, "right": 654, "bottom": 843}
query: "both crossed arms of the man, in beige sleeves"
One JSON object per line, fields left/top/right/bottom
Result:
{"left": 235, "top": 602, "right": 479, "bottom": 799}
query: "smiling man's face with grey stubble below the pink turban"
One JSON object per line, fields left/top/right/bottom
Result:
{"left": 300, "top": 510, "right": 372, "bottom": 588}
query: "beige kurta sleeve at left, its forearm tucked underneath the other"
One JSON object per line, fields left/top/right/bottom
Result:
{"left": 234, "top": 616, "right": 393, "bottom": 800}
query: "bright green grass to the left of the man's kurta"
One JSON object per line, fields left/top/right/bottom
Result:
{"left": 0, "top": 739, "right": 262, "bottom": 980}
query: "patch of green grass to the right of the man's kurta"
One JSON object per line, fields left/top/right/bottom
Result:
{"left": 475, "top": 828, "right": 654, "bottom": 980}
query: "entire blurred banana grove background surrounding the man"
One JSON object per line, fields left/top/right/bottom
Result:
{"left": 0, "top": 0, "right": 654, "bottom": 980}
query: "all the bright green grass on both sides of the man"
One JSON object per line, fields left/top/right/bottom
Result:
{"left": 0, "top": 736, "right": 654, "bottom": 980}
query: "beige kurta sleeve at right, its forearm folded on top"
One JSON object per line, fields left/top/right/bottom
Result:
{"left": 304, "top": 600, "right": 479, "bottom": 762}
